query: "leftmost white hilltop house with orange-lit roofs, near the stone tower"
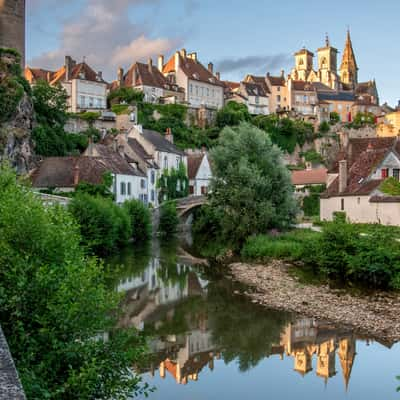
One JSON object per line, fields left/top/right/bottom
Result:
{"left": 25, "top": 56, "right": 107, "bottom": 113}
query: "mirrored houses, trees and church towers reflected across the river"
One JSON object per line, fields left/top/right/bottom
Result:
{"left": 108, "top": 243, "right": 391, "bottom": 396}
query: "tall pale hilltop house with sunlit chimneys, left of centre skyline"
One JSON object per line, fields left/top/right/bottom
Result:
{"left": 158, "top": 49, "right": 224, "bottom": 109}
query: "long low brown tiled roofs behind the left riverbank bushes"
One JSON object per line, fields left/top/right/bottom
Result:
{"left": 32, "top": 156, "right": 136, "bottom": 188}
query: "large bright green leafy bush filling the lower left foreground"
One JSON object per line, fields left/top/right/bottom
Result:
{"left": 0, "top": 167, "right": 144, "bottom": 400}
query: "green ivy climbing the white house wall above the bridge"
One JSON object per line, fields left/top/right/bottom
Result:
{"left": 157, "top": 161, "right": 189, "bottom": 203}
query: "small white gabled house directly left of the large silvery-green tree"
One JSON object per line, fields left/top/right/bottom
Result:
{"left": 187, "top": 151, "right": 212, "bottom": 196}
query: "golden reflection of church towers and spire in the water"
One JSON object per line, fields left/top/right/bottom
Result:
{"left": 274, "top": 318, "right": 356, "bottom": 388}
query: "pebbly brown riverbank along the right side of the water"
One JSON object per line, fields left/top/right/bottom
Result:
{"left": 230, "top": 260, "right": 400, "bottom": 342}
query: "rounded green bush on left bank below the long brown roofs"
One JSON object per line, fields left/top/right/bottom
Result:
{"left": 68, "top": 193, "right": 131, "bottom": 255}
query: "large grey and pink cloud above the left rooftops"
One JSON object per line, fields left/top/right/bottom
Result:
{"left": 30, "top": 0, "right": 182, "bottom": 80}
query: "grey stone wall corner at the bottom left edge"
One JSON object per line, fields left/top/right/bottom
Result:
{"left": 0, "top": 327, "right": 26, "bottom": 400}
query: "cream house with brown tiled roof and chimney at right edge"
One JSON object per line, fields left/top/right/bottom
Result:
{"left": 320, "top": 137, "right": 400, "bottom": 226}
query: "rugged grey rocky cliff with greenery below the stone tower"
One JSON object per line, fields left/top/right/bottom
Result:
{"left": 0, "top": 49, "right": 35, "bottom": 174}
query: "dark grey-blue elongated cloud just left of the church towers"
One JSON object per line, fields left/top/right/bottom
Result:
{"left": 216, "top": 54, "right": 291, "bottom": 74}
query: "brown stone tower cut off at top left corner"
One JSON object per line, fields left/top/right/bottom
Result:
{"left": 0, "top": 0, "right": 25, "bottom": 67}
